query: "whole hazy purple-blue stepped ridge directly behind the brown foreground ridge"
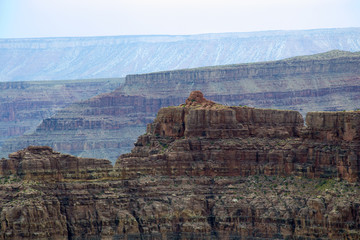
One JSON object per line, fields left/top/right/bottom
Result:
{"left": 2, "top": 51, "right": 360, "bottom": 161}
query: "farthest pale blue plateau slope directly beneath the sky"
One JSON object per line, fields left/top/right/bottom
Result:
{"left": 0, "top": 28, "right": 360, "bottom": 81}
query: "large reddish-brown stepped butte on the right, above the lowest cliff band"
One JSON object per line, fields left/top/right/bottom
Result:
{"left": 115, "top": 92, "right": 360, "bottom": 182}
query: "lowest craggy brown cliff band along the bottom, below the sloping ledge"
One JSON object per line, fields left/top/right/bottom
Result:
{"left": 0, "top": 175, "right": 360, "bottom": 239}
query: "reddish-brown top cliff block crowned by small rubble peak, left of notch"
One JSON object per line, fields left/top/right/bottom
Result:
{"left": 147, "top": 91, "right": 304, "bottom": 138}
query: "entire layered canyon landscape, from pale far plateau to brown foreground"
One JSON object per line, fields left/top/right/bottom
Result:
{"left": 0, "top": 28, "right": 360, "bottom": 240}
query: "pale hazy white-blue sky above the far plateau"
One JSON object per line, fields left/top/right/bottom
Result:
{"left": 0, "top": 0, "right": 360, "bottom": 38}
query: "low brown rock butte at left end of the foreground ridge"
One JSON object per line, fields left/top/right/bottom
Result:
{"left": 0, "top": 146, "right": 112, "bottom": 181}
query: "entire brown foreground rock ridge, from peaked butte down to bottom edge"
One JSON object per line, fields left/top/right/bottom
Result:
{"left": 0, "top": 91, "right": 360, "bottom": 239}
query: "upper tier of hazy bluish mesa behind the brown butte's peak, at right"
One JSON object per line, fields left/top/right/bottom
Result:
{"left": 122, "top": 51, "right": 360, "bottom": 115}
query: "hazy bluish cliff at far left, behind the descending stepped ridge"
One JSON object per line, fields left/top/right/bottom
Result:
{"left": 0, "top": 78, "right": 124, "bottom": 157}
